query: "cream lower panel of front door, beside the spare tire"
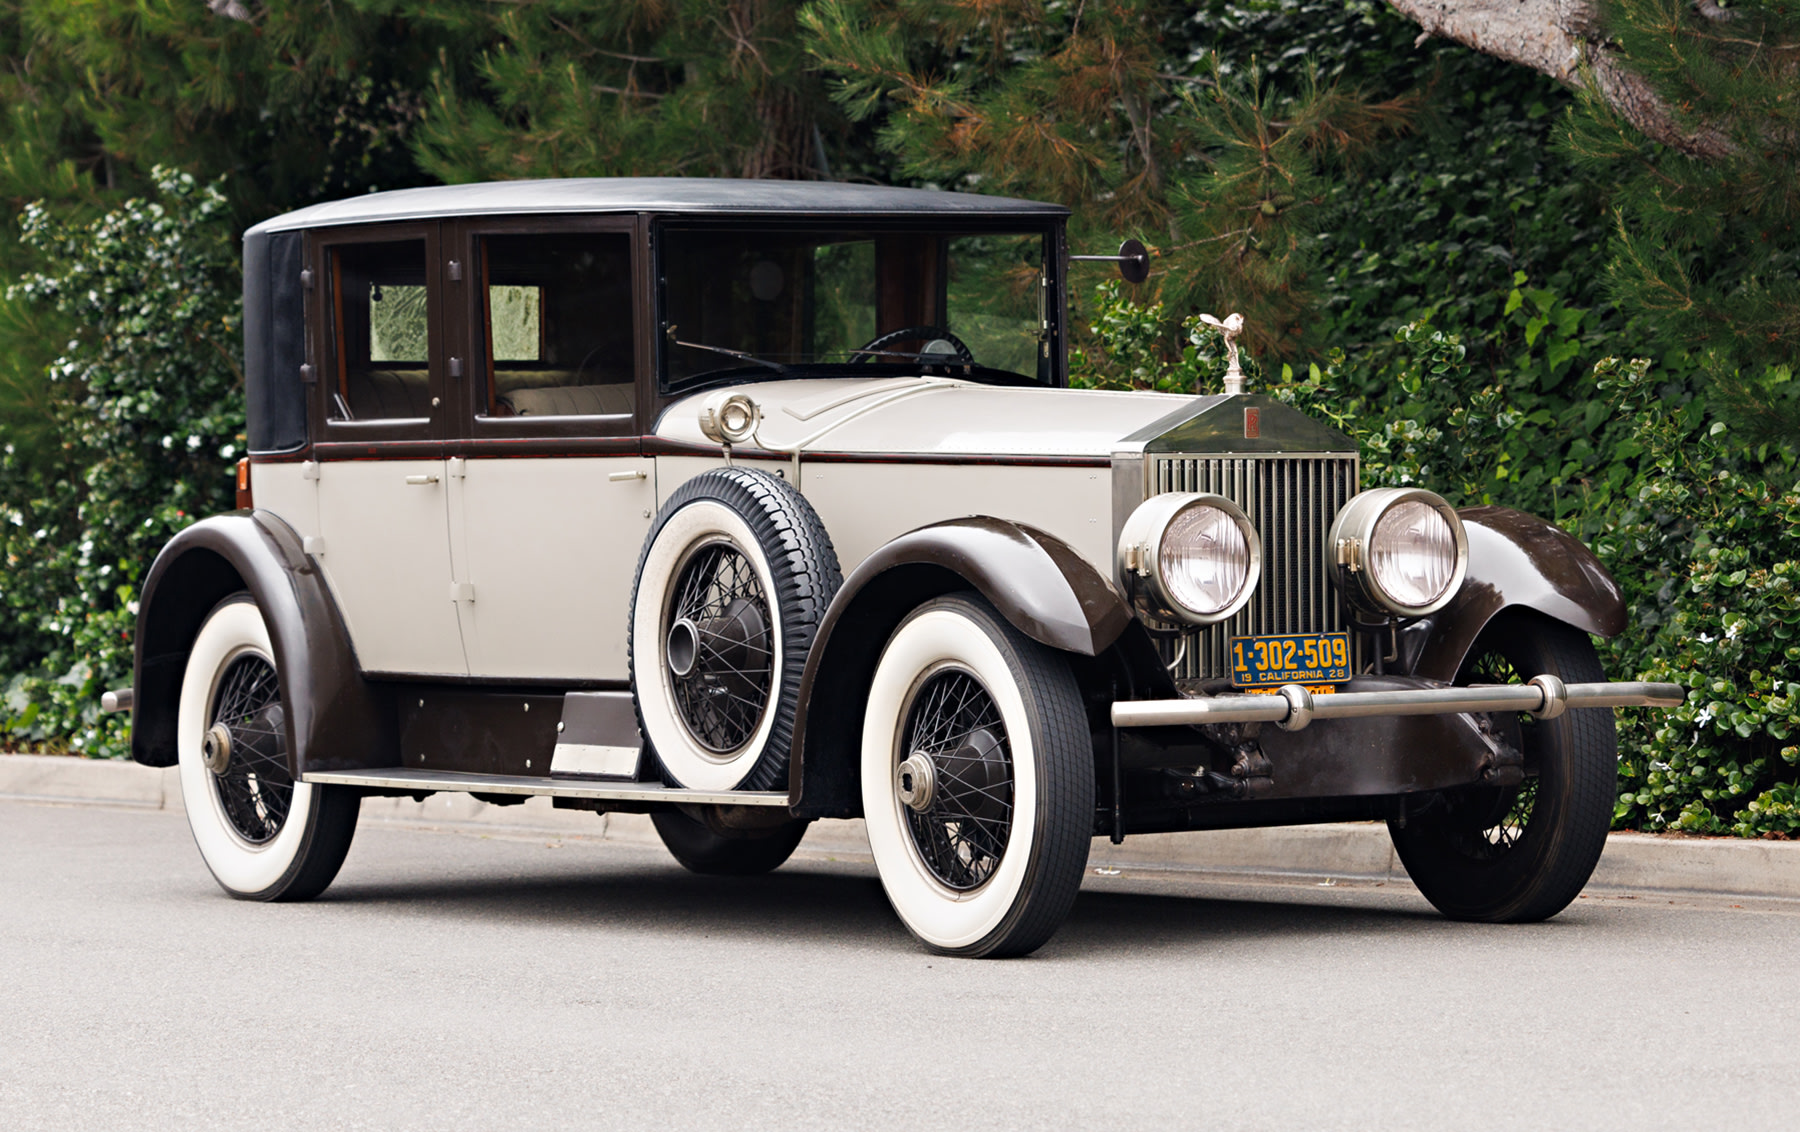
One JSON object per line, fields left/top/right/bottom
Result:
{"left": 450, "top": 455, "right": 657, "bottom": 680}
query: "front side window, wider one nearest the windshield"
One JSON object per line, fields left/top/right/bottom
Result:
{"left": 477, "top": 232, "right": 635, "bottom": 418}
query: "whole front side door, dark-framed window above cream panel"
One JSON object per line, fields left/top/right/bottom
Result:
{"left": 448, "top": 218, "right": 655, "bottom": 682}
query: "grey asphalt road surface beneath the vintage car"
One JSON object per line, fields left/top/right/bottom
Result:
{"left": 0, "top": 803, "right": 1800, "bottom": 1130}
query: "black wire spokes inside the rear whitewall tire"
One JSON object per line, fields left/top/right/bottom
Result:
{"left": 209, "top": 653, "right": 293, "bottom": 846}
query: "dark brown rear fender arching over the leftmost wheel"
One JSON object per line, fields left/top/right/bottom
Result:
{"left": 131, "top": 511, "right": 398, "bottom": 776}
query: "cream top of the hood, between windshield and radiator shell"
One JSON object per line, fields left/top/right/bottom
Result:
{"left": 657, "top": 378, "right": 1197, "bottom": 457}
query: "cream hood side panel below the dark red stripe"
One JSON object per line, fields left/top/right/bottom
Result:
{"left": 657, "top": 455, "right": 1112, "bottom": 578}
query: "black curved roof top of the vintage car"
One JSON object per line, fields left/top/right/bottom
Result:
{"left": 247, "top": 176, "right": 1069, "bottom": 236}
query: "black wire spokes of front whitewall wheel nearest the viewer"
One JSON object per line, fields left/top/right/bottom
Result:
{"left": 896, "top": 668, "right": 1013, "bottom": 893}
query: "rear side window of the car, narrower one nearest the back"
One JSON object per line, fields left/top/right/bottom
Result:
{"left": 328, "top": 239, "right": 432, "bottom": 421}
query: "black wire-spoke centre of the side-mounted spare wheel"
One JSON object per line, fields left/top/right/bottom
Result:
{"left": 668, "top": 540, "right": 776, "bottom": 754}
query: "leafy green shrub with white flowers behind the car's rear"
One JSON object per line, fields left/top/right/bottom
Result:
{"left": 0, "top": 167, "right": 243, "bottom": 754}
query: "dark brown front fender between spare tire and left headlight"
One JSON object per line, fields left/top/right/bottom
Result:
{"left": 788, "top": 517, "right": 1132, "bottom": 817}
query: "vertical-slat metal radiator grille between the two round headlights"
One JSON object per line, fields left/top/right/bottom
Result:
{"left": 1148, "top": 454, "right": 1361, "bottom": 680}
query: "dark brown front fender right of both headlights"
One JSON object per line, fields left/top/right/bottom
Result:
{"left": 1413, "top": 508, "right": 1625, "bottom": 680}
